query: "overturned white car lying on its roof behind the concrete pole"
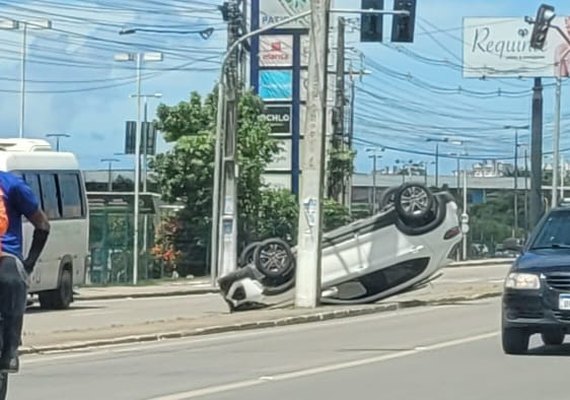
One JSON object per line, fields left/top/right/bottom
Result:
{"left": 218, "top": 182, "right": 462, "bottom": 311}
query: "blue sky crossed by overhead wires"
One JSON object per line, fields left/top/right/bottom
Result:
{"left": 0, "top": 0, "right": 570, "bottom": 173}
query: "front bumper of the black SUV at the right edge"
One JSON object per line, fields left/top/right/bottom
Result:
{"left": 502, "top": 289, "right": 570, "bottom": 332}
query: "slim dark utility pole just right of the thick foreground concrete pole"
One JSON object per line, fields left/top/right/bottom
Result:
{"left": 328, "top": 17, "right": 347, "bottom": 205}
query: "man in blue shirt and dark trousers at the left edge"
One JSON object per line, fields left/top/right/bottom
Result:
{"left": 0, "top": 171, "right": 50, "bottom": 372}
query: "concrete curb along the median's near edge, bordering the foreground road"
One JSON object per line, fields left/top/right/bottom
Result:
{"left": 20, "top": 290, "right": 502, "bottom": 354}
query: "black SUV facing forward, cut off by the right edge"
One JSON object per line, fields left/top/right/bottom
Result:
{"left": 502, "top": 206, "right": 570, "bottom": 354}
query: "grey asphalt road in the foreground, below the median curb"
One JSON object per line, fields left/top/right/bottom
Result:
{"left": 9, "top": 290, "right": 570, "bottom": 400}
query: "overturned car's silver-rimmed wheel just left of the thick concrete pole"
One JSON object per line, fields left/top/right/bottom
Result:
{"left": 253, "top": 238, "right": 295, "bottom": 279}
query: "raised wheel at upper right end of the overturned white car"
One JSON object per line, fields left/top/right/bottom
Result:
{"left": 394, "top": 182, "right": 434, "bottom": 222}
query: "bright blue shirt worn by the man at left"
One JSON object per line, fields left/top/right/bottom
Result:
{"left": 0, "top": 171, "right": 39, "bottom": 258}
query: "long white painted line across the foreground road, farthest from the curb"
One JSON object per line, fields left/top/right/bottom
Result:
{"left": 148, "top": 332, "right": 499, "bottom": 400}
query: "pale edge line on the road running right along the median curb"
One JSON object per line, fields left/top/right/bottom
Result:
{"left": 23, "top": 302, "right": 478, "bottom": 365}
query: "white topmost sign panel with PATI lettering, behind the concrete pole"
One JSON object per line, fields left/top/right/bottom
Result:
{"left": 259, "top": 0, "right": 311, "bottom": 29}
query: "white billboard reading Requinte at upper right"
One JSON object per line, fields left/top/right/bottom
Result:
{"left": 463, "top": 17, "right": 570, "bottom": 78}
